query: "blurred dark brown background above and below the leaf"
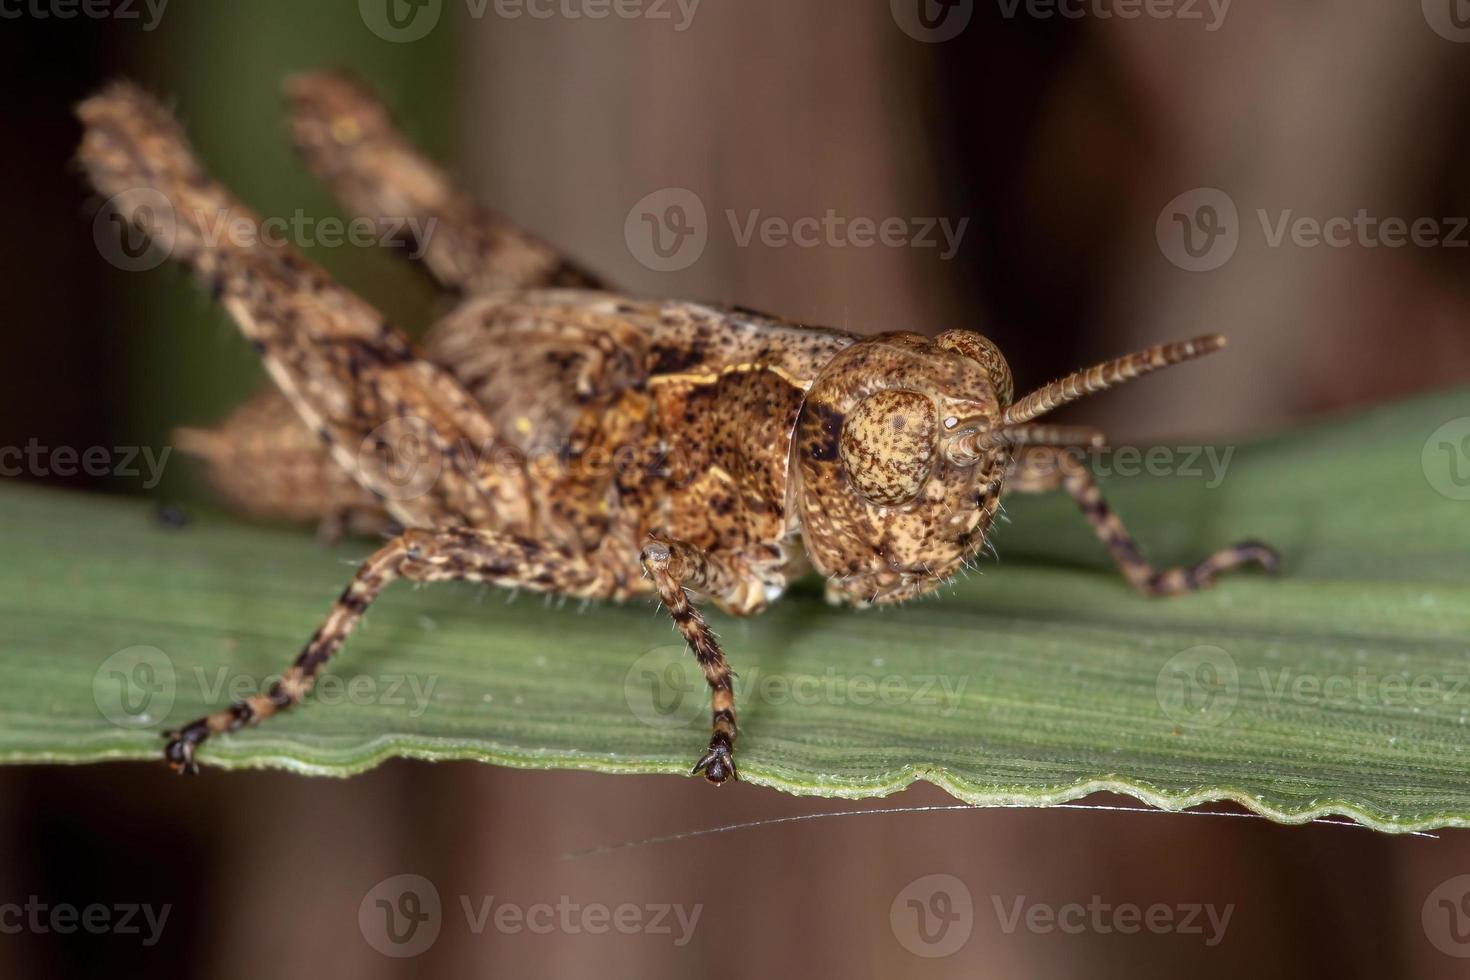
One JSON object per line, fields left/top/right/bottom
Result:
{"left": 0, "top": 0, "right": 1470, "bottom": 979}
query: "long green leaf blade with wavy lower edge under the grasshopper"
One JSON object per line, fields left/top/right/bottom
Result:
{"left": 0, "top": 392, "right": 1470, "bottom": 830}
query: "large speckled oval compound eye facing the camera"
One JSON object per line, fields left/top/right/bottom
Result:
{"left": 838, "top": 391, "right": 939, "bottom": 507}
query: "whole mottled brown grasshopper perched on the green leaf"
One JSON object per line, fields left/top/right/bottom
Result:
{"left": 79, "top": 73, "right": 1277, "bottom": 783}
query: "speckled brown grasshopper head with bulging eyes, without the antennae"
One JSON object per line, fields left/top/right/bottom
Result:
{"left": 792, "top": 331, "right": 1013, "bottom": 602}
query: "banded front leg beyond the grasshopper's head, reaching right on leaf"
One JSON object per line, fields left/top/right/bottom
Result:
{"left": 1005, "top": 447, "right": 1280, "bottom": 595}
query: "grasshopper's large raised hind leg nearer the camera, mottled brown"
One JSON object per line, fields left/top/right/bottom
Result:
{"left": 78, "top": 84, "right": 528, "bottom": 537}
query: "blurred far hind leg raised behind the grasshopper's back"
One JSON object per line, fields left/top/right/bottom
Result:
{"left": 287, "top": 72, "right": 598, "bottom": 294}
